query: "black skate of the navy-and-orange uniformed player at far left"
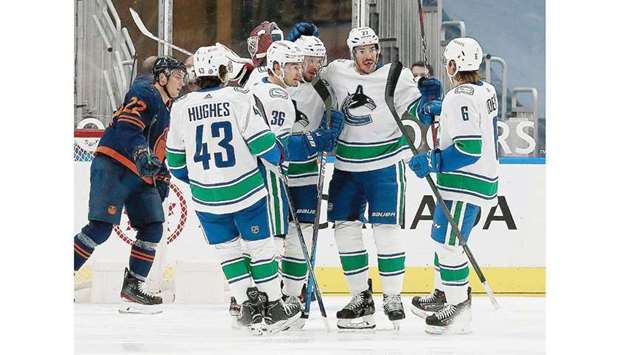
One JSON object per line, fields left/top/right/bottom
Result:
{"left": 118, "top": 268, "right": 163, "bottom": 314}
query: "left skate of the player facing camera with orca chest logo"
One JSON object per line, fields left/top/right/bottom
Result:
{"left": 336, "top": 289, "right": 376, "bottom": 330}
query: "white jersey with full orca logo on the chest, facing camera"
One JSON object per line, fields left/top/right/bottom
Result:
{"left": 320, "top": 59, "right": 420, "bottom": 171}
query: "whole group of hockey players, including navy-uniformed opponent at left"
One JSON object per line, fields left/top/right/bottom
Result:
{"left": 74, "top": 21, "right": 498, "bottom": 334}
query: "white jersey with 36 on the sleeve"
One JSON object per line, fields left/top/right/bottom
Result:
{"left": 251, "top": 79, "right": 295, "bottom": 147}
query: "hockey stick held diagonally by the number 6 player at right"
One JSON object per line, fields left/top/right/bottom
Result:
{"left": 385, "top": 61, "right": 499, "bottom": 309}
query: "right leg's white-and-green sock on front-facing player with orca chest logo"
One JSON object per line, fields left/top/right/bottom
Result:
{"left": 373, "top": 224, "right": 405, "bottom": 295}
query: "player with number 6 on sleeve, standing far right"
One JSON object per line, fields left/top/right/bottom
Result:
{"left": 409, "top": 38, "right": 499, "bottom": 334}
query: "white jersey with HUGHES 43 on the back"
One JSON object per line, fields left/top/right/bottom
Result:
{"left": 167, "top": 87, "right": 276, "bottom": 214}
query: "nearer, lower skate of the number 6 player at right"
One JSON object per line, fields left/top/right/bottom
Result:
{"left": 426, "top": 298, "right": 471, "bottom": 334}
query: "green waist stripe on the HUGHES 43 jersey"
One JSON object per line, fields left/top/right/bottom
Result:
{"left": 190, "top": 170, "right": 263, "bottom": 202}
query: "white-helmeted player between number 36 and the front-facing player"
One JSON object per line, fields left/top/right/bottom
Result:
{"left": 282, "top": 36, "right": 343, "bottom": 327}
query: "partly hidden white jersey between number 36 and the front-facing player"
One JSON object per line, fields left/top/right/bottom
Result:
{"left": 287, "top": 82, "right": 325, "bottom": 186}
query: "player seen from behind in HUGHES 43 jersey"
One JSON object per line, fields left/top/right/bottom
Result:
{"left": 167, "top": 45, "right": 301, "bottom": 333}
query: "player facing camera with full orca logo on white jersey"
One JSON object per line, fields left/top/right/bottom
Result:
{"left": 321, "top": 27, "right": 440, "bottom": 329}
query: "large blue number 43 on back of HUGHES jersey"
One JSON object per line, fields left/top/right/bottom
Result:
{"left": 194, "top": 122, "right": 236, "bottom": 170}
